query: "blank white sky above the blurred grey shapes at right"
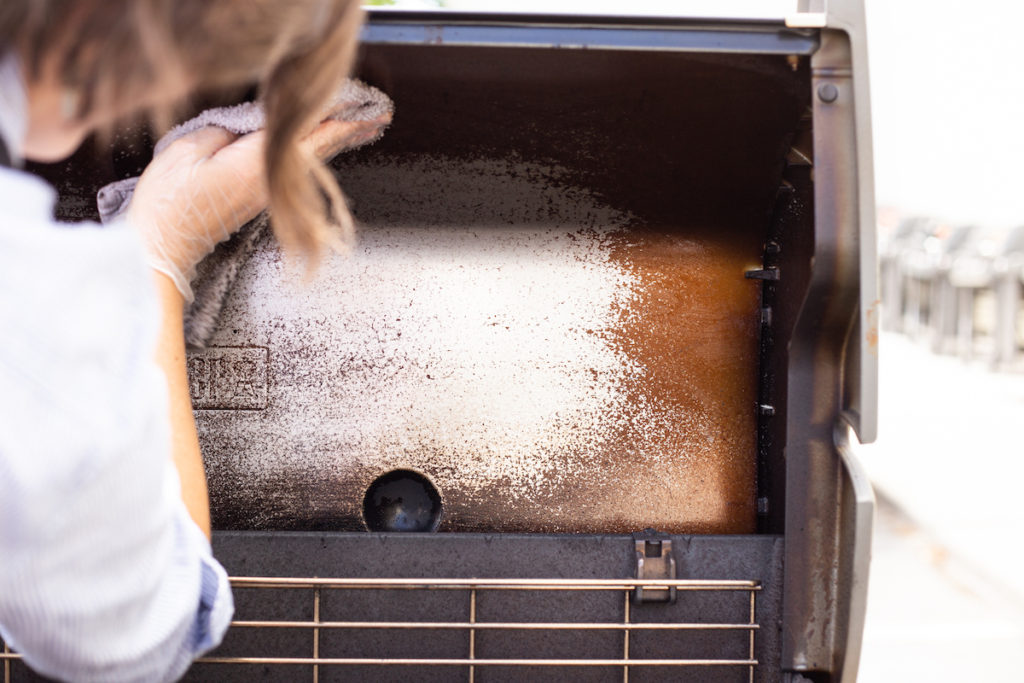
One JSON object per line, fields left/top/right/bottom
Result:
{"left": 372, "top": 0, "right": 1024, "bottom": 227}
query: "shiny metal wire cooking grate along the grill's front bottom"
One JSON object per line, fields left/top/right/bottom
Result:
{"left": 0, "top": 577, "right": 761, "bottom": 683}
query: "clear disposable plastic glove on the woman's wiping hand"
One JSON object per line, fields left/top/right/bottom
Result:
{"left": 126, "top": 117, "right": 390, "bottom": 302}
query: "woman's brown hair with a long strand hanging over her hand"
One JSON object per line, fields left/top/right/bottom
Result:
{"left": 0, "top": 0, "right": 362, "bottom": 256}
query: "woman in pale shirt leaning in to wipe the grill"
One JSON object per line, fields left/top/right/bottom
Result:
{"left": 0, "top": 0, "right": 370, "bottom": 681}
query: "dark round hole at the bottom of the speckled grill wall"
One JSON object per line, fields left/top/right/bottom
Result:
{"left": 362, "top": 470, "right": 441, "bottom": 531}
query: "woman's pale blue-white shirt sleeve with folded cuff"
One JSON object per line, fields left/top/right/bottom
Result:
{"left": 0, "top": 178, "right": 233, "bottom": 682}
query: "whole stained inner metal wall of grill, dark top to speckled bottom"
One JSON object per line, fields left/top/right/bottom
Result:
{"left": 184, "top": 46, "right": 801, "bottom": 533}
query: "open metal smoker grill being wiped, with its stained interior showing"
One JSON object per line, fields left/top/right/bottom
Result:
{"left": 5, "top": 2, "right": 878, "bottom": 683}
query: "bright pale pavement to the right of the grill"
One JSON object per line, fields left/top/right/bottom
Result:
{"left": 859, "top": 335, "right": 1024, "bottom": 683}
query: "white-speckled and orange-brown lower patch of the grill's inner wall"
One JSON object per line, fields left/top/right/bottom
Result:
{"left": 197, "top": 156, "right": 758, "bottom": 532}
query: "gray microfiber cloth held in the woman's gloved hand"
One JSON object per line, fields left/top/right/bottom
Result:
{"left": 96, "top": 80, "right": 394, "bottom": 348}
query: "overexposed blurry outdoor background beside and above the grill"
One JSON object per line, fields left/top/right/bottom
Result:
{"left": 369, "top": 0, "right": 1024, "bottom": 683}
